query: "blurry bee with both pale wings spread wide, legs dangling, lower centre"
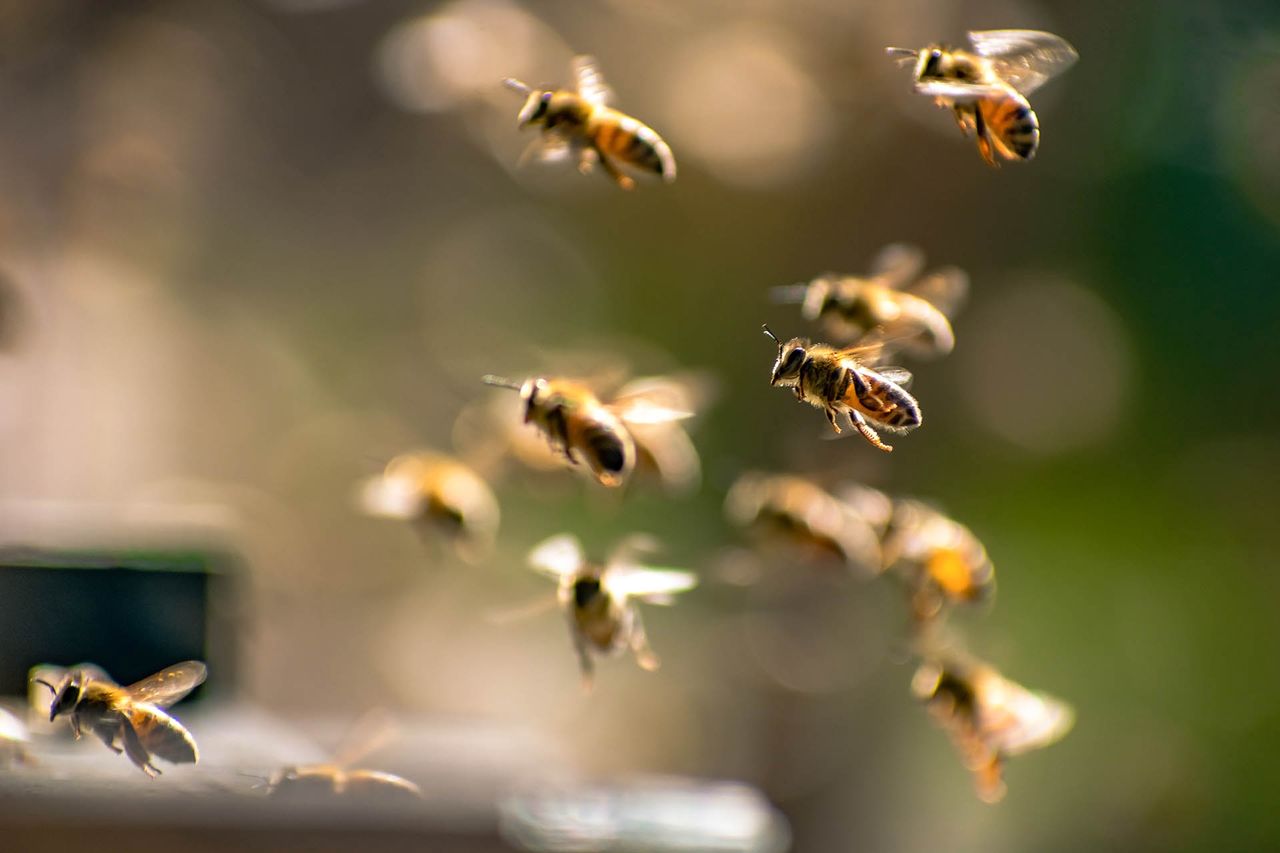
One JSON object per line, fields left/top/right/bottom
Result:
{"left": 529, "top": 533, "right": 698, "bottom": 689}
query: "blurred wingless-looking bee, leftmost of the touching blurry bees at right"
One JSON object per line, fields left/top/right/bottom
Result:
{"left": 724, "top": 473, "right": 881, "bottom": 573}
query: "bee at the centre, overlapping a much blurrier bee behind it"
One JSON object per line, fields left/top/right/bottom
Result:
{"left": 484, "top": 377, "right": 690, "bottom": 488}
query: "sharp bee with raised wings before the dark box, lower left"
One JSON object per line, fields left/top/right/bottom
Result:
{"left": 35, "top": 661, "right": 207, "bottom": 776}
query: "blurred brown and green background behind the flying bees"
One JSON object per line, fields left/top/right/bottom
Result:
{"left": 0, "top": 0, "right": 1280, "bottom": 850}
